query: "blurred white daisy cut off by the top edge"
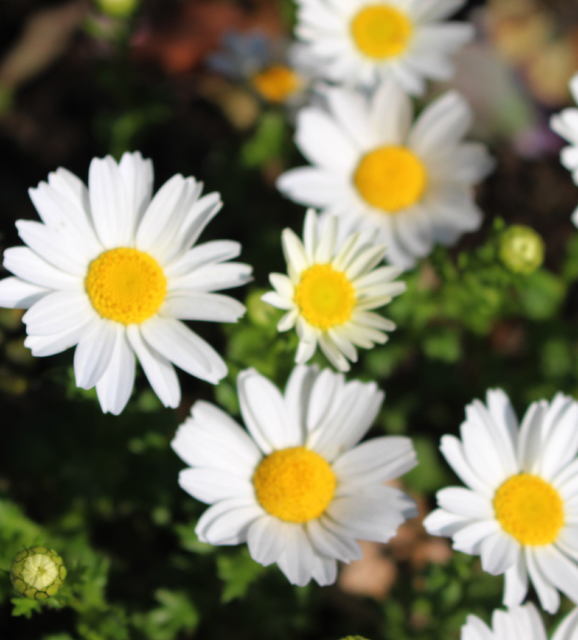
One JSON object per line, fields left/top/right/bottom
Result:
{"left": 295, "top": 0, "right": 474, "bottom": 95}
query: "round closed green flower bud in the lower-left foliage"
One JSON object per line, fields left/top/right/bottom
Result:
{"left": 10, "top": 547, "right": 66, "bottom": 600}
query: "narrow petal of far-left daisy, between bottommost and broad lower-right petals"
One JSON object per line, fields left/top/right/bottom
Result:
{"left": 126, "top": 324, "right": 181, "bottom": 409}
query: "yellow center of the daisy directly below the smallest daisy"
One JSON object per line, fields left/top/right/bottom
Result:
{"left": 253, "top": 447, "right": 337, "bottom": 522}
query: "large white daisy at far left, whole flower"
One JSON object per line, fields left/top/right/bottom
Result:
{"left": 0, "top": 153, "right": 251, "bottom": 414}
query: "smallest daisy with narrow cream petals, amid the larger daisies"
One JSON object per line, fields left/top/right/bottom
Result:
{"left": 263, "top": 209, "right": 406, "bottom": 371}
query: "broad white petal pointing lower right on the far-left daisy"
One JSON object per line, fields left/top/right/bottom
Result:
{"left": 141, "top": 318, "right": 227, "bottom": 384}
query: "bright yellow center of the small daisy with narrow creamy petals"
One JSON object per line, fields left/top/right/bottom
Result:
{"left": 294, "top": 264, "right": 356, "bottom": 329}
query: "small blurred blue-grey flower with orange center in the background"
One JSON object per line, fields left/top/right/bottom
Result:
{"left": 208, "top": 31, "right": 313, "bottom": 105}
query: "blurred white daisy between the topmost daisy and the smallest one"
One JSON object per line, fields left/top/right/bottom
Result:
{"left": 277, "top": 83, "right": 492, "bottom": 267}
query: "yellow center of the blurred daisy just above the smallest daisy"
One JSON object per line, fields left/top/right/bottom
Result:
{"left": 353, "top": 146, "right": 427, "bottom": 213}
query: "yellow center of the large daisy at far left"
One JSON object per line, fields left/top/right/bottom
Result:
{"left": 84, "top": 247, "right": 167, "bottom": 324}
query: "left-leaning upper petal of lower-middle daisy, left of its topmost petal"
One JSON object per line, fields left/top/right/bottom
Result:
{"left": 237, "top": 369, "right": 303, "bottom": 453}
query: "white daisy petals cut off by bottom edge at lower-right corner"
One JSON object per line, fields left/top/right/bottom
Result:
{"left": 461, "top": 603, "right": 578, "bottom": 640}
